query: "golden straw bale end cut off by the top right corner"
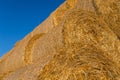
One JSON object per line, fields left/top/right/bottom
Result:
{"left": 94, "top": 0, "right": 120, "bottom": 38}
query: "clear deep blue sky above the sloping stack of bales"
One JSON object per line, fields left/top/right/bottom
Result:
{"left": 0, "top": 0, "right": 65, "bottom": 57}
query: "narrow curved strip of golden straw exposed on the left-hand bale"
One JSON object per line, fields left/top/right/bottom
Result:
{"left": 24, "top": 33, "right": 44, "bottom": 64}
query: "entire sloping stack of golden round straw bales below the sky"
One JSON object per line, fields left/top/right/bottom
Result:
{"left": 0, "top": 0, "right": 120, "bottom": 80}
